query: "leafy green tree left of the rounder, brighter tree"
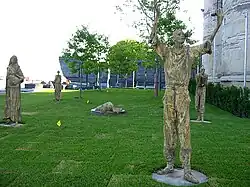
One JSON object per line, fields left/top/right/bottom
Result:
{"left": 63, "top": 25, "right": 109, "bottom": 86}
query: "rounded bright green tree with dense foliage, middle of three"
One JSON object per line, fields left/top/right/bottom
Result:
{"left": 108, "top": 40, "right": 152, "bottom": 86}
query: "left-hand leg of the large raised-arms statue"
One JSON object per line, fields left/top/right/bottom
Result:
{"left": 157, "top": 90, "right": 177, "bottom": 175}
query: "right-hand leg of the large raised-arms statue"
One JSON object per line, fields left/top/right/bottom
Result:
{"left": 177, "top": 89, "right": 199, "bottom": 184}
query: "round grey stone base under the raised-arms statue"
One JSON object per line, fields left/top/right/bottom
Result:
{"left": 152, "top": 169, "right": 208, "bottom": 186}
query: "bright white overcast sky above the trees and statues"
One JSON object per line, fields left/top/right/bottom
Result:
{"left": 0, "top": 0, "right": 203, "bottom": 80}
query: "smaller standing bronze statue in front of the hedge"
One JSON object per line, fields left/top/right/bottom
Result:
{"left": 195, "top": 68, "right": 208, "bottom": 121}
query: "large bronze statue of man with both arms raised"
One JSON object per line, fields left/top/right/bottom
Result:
{"left": 149, "top": 10, "right": 223, "bottom": 184}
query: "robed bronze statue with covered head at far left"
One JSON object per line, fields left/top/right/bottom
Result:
{"left": 4, "top": 56, "right": 24, "bottom": 124}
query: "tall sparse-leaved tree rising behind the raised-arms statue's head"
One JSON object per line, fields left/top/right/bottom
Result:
{"left": 116, "top": 0, "right": 196, "bottom": 45}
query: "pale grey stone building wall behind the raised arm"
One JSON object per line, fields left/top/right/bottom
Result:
{"left": 202, "top": 0, "right": 250, "bottom": 86}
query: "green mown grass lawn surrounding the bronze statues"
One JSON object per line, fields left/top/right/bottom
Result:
{"left": 0, "top": 90, "right": 250, "bottom": 187}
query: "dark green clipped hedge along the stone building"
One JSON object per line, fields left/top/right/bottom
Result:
{"left": 189, "top": 79, "right": 250, "bottom": 118}
